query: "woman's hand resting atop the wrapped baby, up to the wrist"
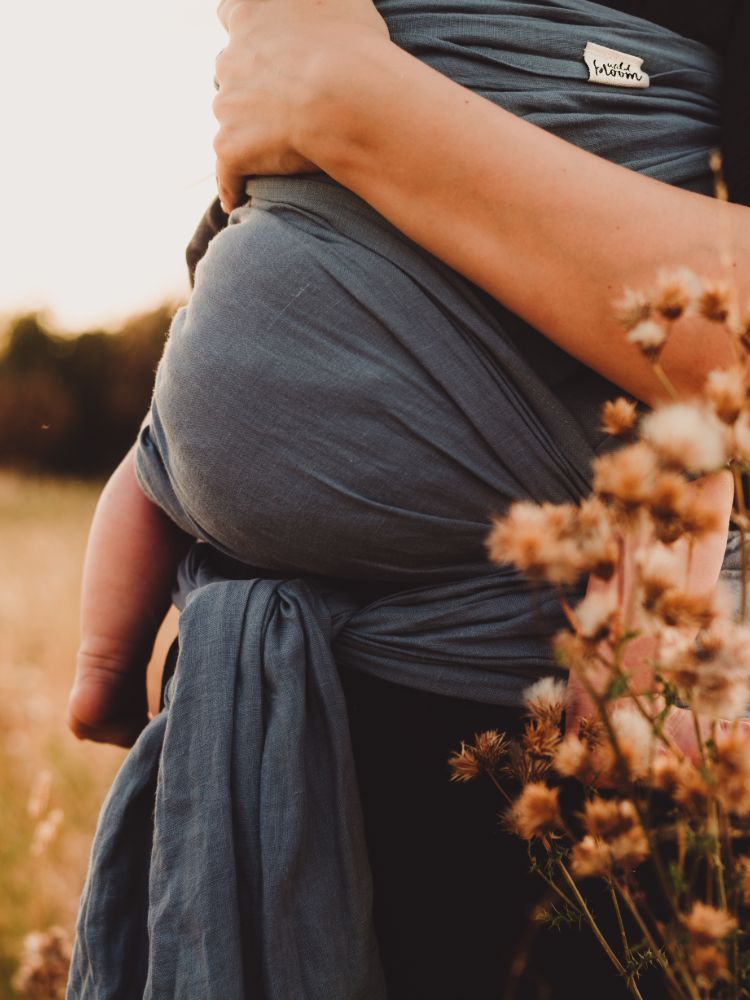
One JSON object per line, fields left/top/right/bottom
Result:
{"left": 214, "top": 0, "right": 388, "bottom": 211}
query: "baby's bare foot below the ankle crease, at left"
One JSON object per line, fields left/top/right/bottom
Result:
{"left": 67, "top": 649, "right": 149, "bottom": 747}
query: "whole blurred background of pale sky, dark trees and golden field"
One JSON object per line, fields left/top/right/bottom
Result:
{"left": 0, "top": 0, "right": 223, "bottom": 1000}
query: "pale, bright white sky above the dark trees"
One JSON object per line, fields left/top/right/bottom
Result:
{"left": 0, "top": 0, "right": 224, "bottom": 331}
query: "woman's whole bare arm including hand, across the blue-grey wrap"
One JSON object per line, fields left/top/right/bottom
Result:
{"left": 215, "top": 0, "right": 750, "bottom": 403}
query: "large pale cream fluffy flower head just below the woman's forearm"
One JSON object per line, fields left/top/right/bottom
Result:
{"left": 641, "top": 403, "right": 728, "bottom": 474}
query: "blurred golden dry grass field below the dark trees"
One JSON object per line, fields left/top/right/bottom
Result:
{"left": 0, "top": 473, "right": 175, "bottom": 1000}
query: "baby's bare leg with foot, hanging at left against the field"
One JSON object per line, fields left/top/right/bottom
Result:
{"left": 68, "top": 451, "right": 191, "bottom": 746}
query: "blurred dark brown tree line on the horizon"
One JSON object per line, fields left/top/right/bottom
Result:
{"left": 0, "top": 306, "right": 173, "bottom": 476}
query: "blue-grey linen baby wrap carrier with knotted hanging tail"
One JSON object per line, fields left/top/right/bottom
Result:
{"left": 68, "top": 0, "right": 720, "bottom": 1000}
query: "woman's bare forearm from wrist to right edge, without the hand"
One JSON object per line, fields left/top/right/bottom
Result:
{"left": 296, "top": 37, "right": 750, "bottom": 402}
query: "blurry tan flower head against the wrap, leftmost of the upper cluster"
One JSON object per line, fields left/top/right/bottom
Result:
{"left": 487, "top": 501, "right": 581, "bottom": 584}
